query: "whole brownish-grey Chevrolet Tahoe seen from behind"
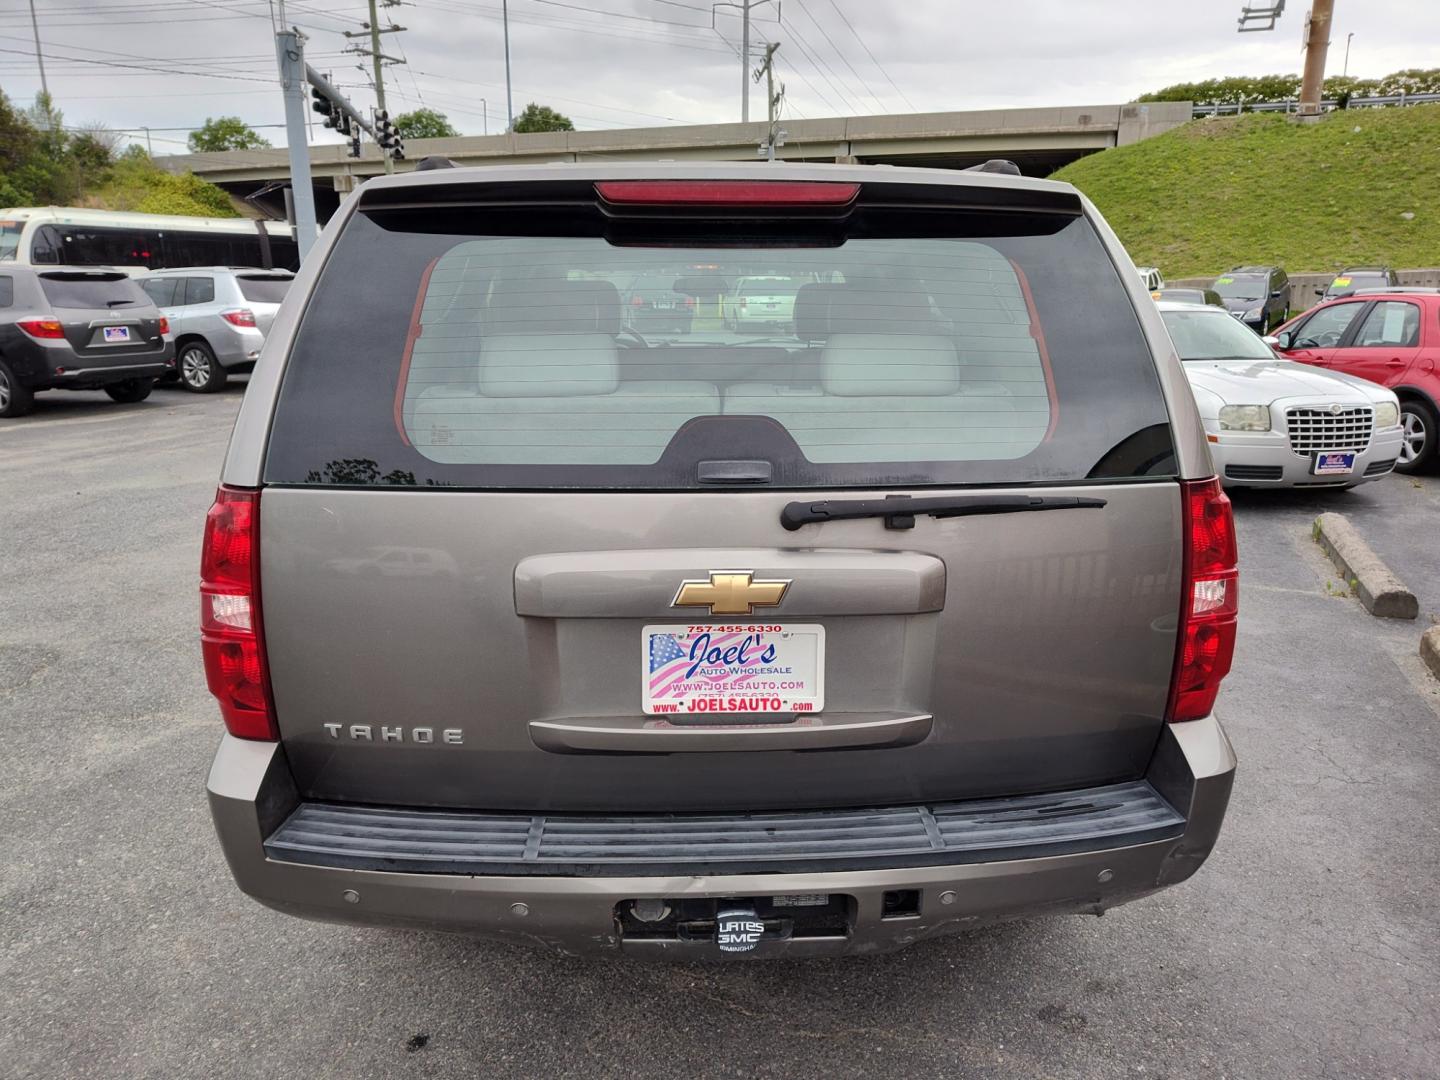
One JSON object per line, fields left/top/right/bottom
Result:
{"left": 200, "top": 164, "right": 1237, "bottom": 958}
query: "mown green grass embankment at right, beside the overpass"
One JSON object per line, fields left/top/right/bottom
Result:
{"left": 1053, "top": 105, "right": 1440, "bottom": 278}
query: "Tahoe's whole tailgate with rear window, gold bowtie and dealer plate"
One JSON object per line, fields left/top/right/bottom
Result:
{"left": 261, "top": 177, "right": 1185, "bottom": 811}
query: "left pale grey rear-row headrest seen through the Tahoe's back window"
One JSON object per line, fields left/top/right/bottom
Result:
{"left": 480, "top": 334, "right": 621, "bottom": 397}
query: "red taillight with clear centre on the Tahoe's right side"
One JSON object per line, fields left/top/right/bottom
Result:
{"left": 1165, "top": 478, "right": 1240, "bottom": 723}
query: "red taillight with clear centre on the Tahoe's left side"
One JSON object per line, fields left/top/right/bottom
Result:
{"left": 200, "top": 487, "right": 278, "bottom": 739}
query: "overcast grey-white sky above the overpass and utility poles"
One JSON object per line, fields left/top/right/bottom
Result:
{"left": 0, "top": 0, "right": 1440, "bottom": 156}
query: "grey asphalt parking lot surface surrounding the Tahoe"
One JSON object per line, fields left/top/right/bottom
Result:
{"left": 0, "top": 384, "right": 1440, "bottom": 1080}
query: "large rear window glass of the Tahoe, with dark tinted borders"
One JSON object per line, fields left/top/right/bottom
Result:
{"left": 266, "top": 197, "right": 1174, "bottom": 488}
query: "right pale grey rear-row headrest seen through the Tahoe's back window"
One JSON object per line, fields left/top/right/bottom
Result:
{"left": 819, "top": 334, "right": 960, "bottom": 397}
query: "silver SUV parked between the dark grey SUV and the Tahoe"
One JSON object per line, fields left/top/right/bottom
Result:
{"left": 138, "top": 266, "right": 295, "bottom": 393}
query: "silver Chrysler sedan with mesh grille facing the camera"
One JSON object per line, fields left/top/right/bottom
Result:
{"left": 1158, "top": 301, "right": 1403, "bottom": 487}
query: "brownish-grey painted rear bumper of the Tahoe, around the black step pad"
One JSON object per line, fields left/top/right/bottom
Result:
{"left": 209, "top": 719, "right": 1236, "bottom": 959}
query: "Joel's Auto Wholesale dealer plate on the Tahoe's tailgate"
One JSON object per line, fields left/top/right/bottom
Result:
{"left": 641, "top": 624, "right": 825, "bottom": 719}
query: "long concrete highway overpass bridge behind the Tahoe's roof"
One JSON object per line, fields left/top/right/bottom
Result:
{"left": 158, "top": 101, "right": 1191, "bottom": 220}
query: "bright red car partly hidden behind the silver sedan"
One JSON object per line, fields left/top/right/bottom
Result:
{"left": 1266, "top": 288, "right": 1440, "bottom": 472}
